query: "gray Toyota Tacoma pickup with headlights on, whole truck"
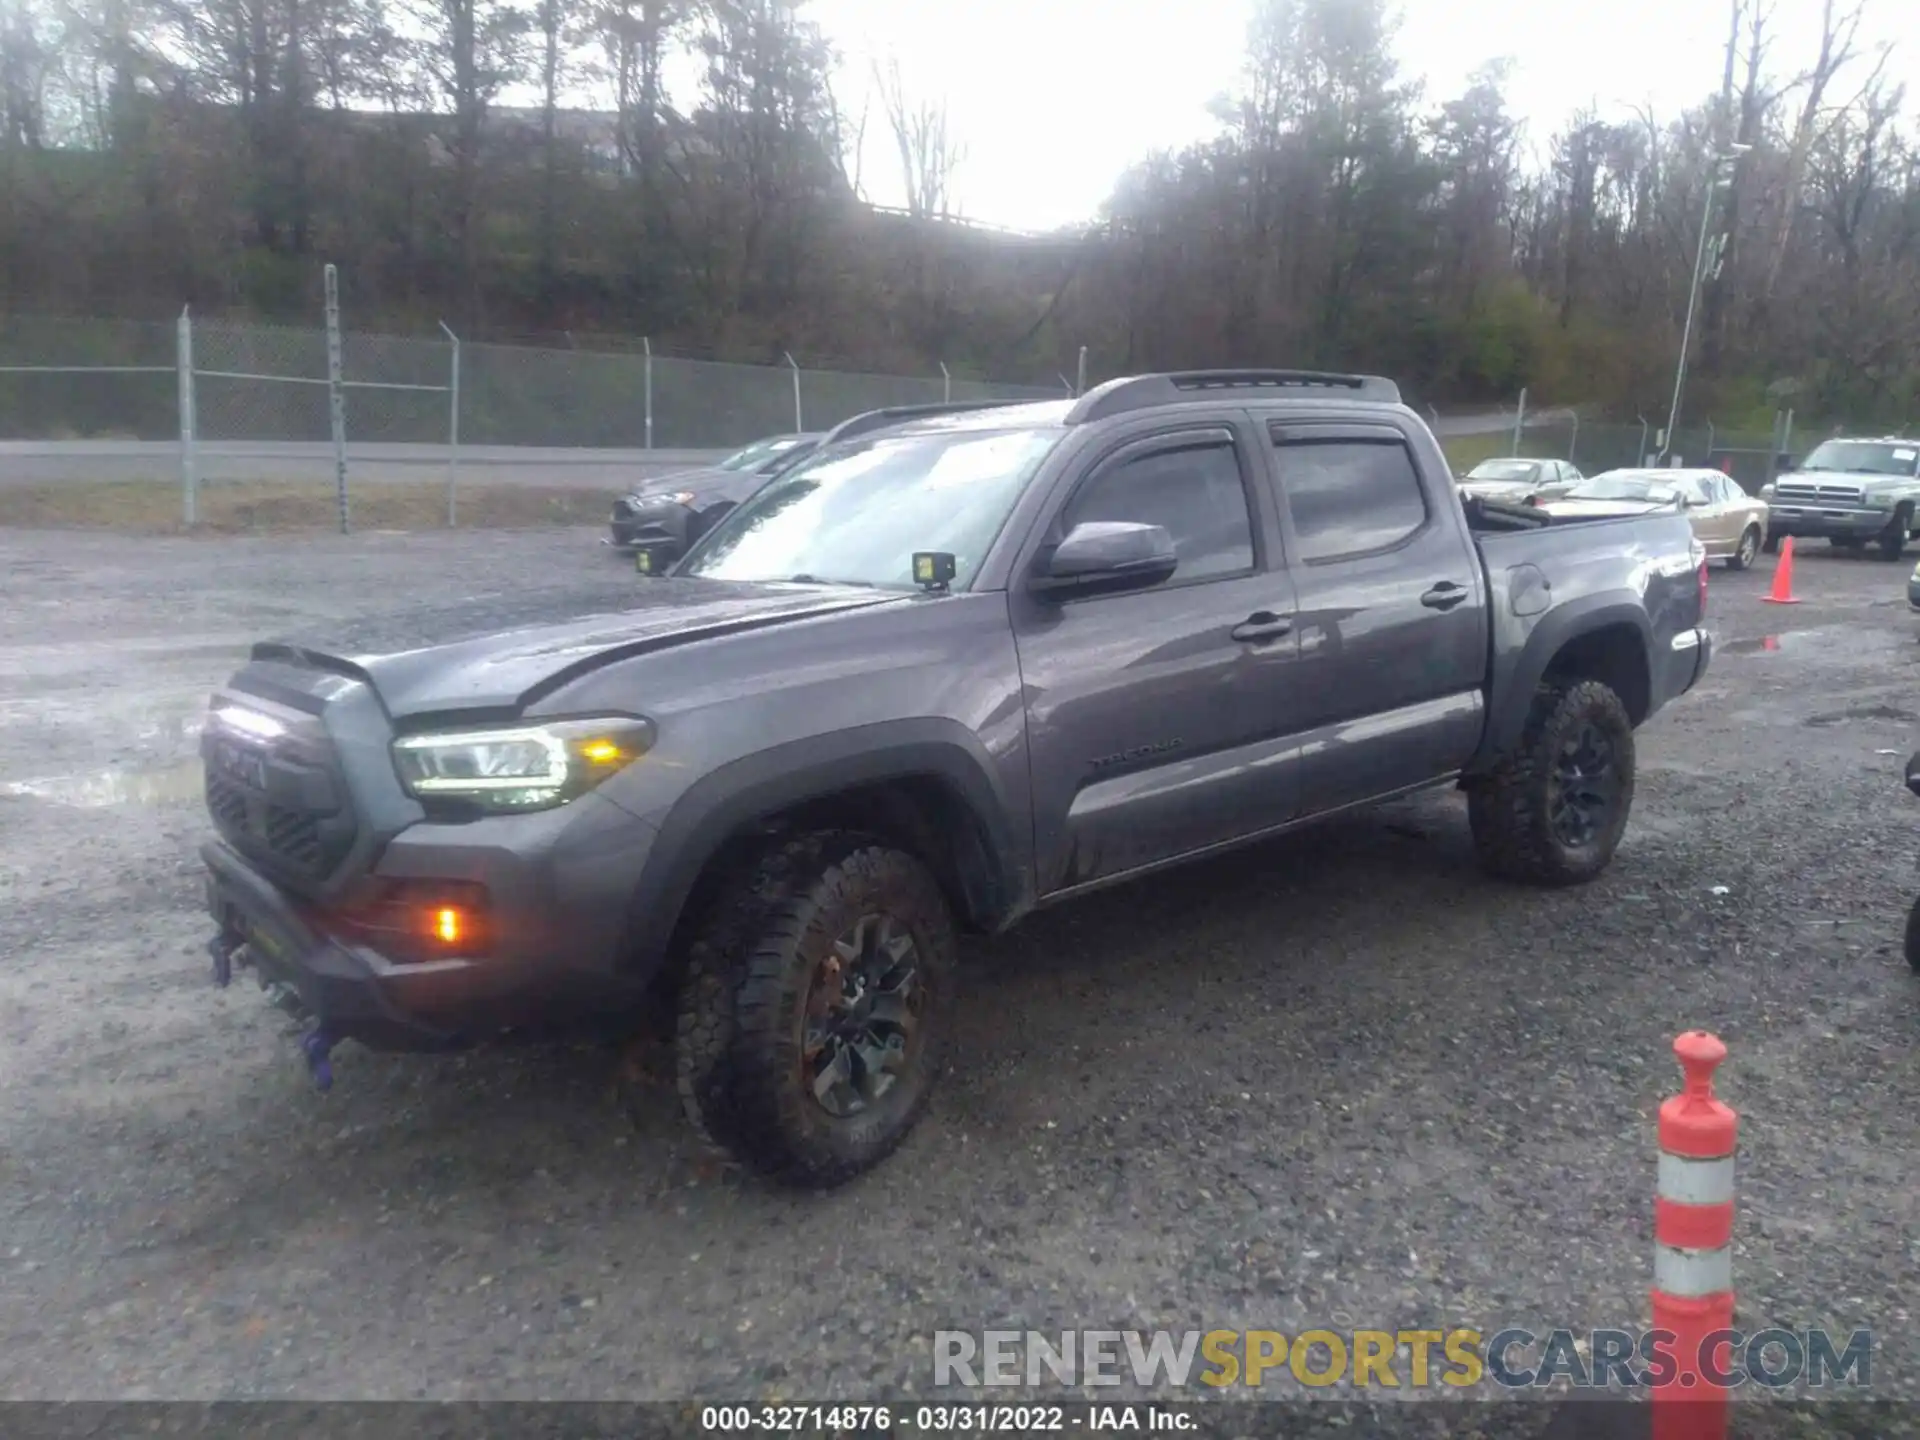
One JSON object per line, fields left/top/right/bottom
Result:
{"left": 202, "top": 371, "right": 1709, "bottom": 1185}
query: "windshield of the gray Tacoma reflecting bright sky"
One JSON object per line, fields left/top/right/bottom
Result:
{"left": 674, "top": 428, "right": 1064, "bottom": 589}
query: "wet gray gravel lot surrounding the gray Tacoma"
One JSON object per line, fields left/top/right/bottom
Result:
{"left": 0, "top": 532, "right": 1920, "bottom": 1400}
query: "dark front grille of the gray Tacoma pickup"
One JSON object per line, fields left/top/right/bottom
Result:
{"left": 202, "top": 726, "right": 355, "bottom": 881}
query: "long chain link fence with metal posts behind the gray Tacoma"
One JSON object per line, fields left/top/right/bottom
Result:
{"left": 0, "top": 311, "right": 1071, "bottom": 524}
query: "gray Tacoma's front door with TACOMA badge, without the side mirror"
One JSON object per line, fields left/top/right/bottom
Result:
{"left": 1008, "top": 413, "right": 1300, "bottom": 895}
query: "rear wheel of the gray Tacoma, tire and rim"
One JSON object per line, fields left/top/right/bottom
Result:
{"left": 1467, "top": 680, "right": 1634, "bottom": 885}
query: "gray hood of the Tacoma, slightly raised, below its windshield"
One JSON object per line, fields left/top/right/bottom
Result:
{"left": 253, "top": 578, "right": 908, "bottom": 720}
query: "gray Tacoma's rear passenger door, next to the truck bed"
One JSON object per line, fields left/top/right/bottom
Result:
{"left": 1269, "top": 420, "right": 1488, "bottom": 814}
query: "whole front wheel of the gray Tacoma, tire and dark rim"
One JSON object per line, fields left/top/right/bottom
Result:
{"left": 678, "top": 833, "right": 954, "bottom": 1188}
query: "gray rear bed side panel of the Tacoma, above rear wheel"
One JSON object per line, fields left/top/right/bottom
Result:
{"left": 1471, "top": 513, "right": 1703, "bottom": 768}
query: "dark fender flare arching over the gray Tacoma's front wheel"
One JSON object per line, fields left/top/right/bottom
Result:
{"left": 624, "top": 718, "right": 1033, "bottom": 975}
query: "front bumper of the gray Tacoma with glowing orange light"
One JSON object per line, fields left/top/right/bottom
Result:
{"left": 200, "top": 797, "right": 651, "bottom": 1050}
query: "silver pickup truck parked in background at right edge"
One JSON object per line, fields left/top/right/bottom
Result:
{"left": 1761, "top": 436, "right": 1920, "bottom": 561}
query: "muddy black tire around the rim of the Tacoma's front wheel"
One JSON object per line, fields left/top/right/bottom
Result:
{"left": 676, "top": 831, "right": 954, "bottom": 1188}
